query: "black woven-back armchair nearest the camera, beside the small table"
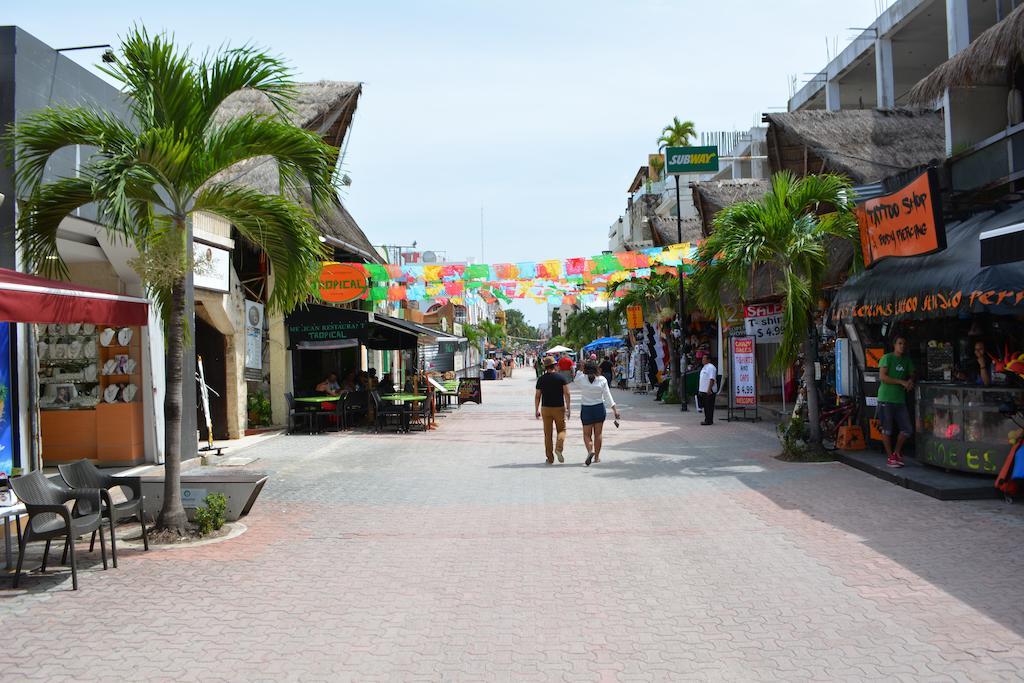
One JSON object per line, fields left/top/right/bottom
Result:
{"left": 10, "top": 470, "right": 106, "bottom": 591}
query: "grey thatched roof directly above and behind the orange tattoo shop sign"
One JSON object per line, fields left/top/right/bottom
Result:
{"left": 764, "top": 109, "right": 946, "bottom": 184}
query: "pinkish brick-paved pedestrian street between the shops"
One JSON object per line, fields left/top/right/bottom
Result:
{"left": 6, "top": 370, "right": 1024, "bottom": 681}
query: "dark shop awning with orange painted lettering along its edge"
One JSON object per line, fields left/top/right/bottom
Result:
{"left": 829, "top": 203, "right": 1024, "bottom": 323}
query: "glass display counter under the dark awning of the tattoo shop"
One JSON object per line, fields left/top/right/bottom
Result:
{"left": 915, "top": 382, "right": 1024, "bottom": 476}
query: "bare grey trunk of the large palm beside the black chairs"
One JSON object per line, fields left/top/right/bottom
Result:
{"left": 157, "top": 278, "right": 188, "bottom": 531}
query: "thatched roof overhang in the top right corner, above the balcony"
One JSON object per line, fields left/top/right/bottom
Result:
{"left": 907, "top": 5, "right": 1024, "bottom": 104}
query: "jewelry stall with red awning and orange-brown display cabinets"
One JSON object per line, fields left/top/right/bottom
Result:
{"left": 0, "top": 269, "right": 148, "bottom": 469}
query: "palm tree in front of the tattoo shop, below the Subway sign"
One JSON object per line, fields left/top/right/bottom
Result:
{"left": 693, "top": 171, "right": 861, "bottom": 443}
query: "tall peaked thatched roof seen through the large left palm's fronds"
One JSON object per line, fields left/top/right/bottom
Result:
{"left": 209, "top": 81, "right": 382, "bottom": 263}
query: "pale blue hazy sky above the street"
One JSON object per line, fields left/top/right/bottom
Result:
{"left": 6, "top": 0, "right": 887, "bottom": 323}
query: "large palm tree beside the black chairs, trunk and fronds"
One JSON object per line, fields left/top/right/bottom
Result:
{"left": 11, "top": 28, "right": 338, "bottom": 530}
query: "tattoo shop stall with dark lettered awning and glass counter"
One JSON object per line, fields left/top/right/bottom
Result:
{"left": 829, "top": 200, "right": 1024, "bottom": 476}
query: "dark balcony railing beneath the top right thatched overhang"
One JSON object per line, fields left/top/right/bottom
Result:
{"left": 949, "top": 124, "right": 1024, "bottom": 193}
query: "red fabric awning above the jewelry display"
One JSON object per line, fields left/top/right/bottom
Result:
{"left": 0, "top": 268, "right": 150, "bottom": 326}
